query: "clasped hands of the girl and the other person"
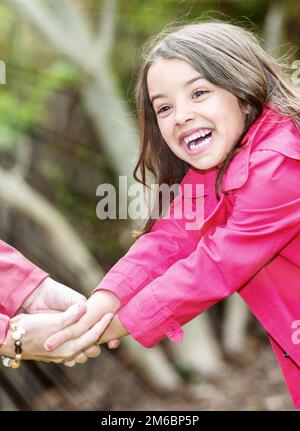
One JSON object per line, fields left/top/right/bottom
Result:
{"left": 0, "top": 277, "right": 127, "bottom": 367}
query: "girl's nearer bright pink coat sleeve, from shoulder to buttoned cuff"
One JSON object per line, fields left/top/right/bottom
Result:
{"left": 118, "top": 150, "right": 300, "bottom": 347}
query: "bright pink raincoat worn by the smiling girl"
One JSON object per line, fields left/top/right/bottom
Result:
{"left": 96, "top": 107, "right": 300, "bottom": 408}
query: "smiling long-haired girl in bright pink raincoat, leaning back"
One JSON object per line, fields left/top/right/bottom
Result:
{"left": 44, "top": 22, "right": 300, "bottom": 408}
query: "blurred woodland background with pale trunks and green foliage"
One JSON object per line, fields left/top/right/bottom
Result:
{"left": 0, "top": 0, "right": 300, "bottom": 410}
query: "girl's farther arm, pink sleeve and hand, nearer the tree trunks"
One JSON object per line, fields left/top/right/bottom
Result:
{"left": 45, "top": 169, "right": 213, "bottom": 350}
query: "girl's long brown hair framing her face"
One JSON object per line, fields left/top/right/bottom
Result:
{"left": 133, "top": 20, "right": 300, "bottom": 237}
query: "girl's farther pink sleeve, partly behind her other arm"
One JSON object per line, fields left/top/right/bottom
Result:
{"left": 94, "top": 171, "right": 204, "bottom": 307}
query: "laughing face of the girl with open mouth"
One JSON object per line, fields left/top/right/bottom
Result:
{"left": 147, "top": 58, "right": 245, "bottom": 169}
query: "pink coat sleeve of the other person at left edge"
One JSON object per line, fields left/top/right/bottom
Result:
{"left": 0, "top": 240, "right": 48, "bottom": 345}
